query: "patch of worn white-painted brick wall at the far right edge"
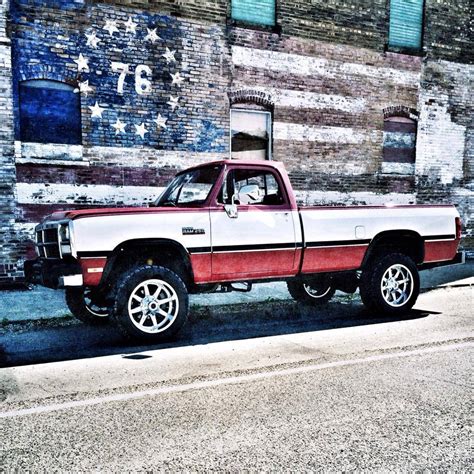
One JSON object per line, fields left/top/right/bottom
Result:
{"left": 416, "top": 60, "right": 474, "bottom": 249}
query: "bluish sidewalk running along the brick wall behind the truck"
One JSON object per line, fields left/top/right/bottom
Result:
{"left": 0, "top": 260, "right": 474, "bottom": 324}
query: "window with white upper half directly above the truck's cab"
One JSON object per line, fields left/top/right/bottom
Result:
{"left": 231, "top": 109, "right": 271, "bottom": 160}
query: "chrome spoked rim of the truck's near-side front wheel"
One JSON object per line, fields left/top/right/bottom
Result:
{"left": 128, "top": 279, "right": 179, "bottom": 334}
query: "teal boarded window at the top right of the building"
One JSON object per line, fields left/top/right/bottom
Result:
{"left": 388, "top": 0, "right": 423, "bottom": 50}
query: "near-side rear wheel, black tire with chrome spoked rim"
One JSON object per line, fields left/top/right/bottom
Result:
{"left": 360, "top": 253, "right": 420, "bottom": 314}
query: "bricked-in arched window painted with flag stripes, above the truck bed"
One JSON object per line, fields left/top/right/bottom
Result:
{"left": 382, "top": 115, "right": 417, "bottom": 174}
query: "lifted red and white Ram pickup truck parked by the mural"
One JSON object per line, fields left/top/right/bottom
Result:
{"left": 25, "top": 161, "right": 463, "bottom": 341}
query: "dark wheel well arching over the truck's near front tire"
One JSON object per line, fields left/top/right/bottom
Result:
{"left": 100, "top": 239, "right": 194, "bottom": 288}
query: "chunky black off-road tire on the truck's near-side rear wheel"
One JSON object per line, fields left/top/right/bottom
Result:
{"left": 360, "top": 252, "right": 420, "bottom": 315}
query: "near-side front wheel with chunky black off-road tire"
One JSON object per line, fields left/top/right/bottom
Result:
{"left": 112, "top": 265, "right": 189, "bottom": 343}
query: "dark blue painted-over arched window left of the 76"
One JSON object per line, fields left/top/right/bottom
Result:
{"left": 20, "top": 80, "right": 81, "bottom": 145}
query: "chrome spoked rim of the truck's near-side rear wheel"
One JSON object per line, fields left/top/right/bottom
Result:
{"left": 380, "top": 263, "right": 413, "bottom": 308}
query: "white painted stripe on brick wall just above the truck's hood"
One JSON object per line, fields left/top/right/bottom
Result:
{"left": 16, "top": 183, "right": 164, "bottom": 206}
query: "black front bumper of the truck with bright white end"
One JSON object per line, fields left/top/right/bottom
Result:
{"left": 23, "top": 258, "right": 83, "bottom": 289}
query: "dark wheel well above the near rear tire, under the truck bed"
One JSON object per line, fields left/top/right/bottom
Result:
{"left": 362, "top": 230, "right": 425, "bottom": 268}
